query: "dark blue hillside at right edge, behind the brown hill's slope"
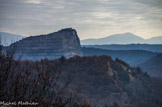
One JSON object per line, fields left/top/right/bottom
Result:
{"left": 139, "top": 53, "right": 162, "bottom": 78}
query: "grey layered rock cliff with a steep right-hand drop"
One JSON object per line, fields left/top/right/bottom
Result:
{"left": 8, "top": 28, "right": 82, "bottom": 60}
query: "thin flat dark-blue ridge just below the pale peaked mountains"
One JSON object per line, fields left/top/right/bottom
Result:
{"left": 82, "top": 44, "right": 162, "bottom": 52}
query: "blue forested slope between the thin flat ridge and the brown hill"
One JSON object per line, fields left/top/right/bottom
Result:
{"left": 82, "top": 48, "right": 157, "bottom": 66}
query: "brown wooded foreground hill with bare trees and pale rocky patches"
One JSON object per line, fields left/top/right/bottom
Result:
{"left": 0, "top": 53, "right": 162, "bottom": 107}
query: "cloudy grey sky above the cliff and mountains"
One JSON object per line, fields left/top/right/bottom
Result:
{"left": 0, "top": 0, "right": 162, "bottom": 39}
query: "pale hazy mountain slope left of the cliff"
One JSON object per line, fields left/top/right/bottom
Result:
{"left": 0, "top": 32, "right": 25, "bottom": 46}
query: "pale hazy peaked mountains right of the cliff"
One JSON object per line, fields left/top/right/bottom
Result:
{"left": 81, "top": 33, "right": 162, "bottom": 45}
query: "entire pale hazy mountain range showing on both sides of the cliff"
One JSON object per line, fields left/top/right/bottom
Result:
{"left": 0, "top": 32, "right": 162, "bottom": 46}
